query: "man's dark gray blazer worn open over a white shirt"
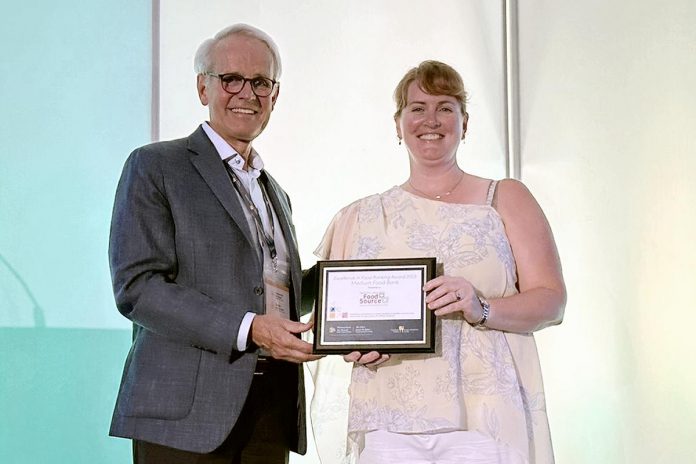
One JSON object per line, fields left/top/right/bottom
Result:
{"left": 109, "top": 127, "right": 306, "bottom": 454}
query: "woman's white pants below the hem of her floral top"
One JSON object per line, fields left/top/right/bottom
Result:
{"left": 358, "top": 430, "right": 526, "bottom": 464}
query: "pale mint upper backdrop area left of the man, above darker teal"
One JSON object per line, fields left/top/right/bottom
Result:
{"left": 0, "top": 0, "right": 152, "bottom": 328}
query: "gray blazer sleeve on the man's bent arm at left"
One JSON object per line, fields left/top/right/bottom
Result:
{"left": 109, "top": 147, "right": 245, "bottom": 356}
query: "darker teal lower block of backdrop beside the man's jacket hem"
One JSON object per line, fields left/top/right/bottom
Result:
{"left": 0, "top": 328, "right": 130, "bottom": 464}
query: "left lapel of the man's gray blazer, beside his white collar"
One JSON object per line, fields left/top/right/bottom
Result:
{"left": 188, "top": 127, "right": 256, "bottom": 254}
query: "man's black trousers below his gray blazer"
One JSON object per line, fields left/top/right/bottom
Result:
{"left": 133, "top": 361, "right": 297, "bottom": 464}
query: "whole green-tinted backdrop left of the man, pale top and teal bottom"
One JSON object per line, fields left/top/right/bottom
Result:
{"left": 0, "top": 0, "right": 152, "bottom": 464}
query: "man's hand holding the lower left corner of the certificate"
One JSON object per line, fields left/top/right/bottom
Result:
{"left": 251, "top": 315, "right": 322, "bottom": 363}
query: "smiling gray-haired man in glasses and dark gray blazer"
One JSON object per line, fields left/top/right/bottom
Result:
{"left": 109, "top": 24, "right": 316, "bottom": 464}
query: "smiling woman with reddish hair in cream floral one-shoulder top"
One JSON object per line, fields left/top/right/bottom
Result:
{"left": 313, "top": 61, "right": 566, "bottom": 464}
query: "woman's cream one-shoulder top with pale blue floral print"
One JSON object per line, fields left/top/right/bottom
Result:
{"left": 311, "top": 183, "right": 553, "bottom": 463}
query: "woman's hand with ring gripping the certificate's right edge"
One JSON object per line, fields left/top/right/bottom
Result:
{"left": 423, "top": 276, "right": 483, "bottom": 324}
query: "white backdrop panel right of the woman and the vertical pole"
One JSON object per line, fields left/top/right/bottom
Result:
{"left": 519, "top": 0, "right": 696, "bottom": 464}
